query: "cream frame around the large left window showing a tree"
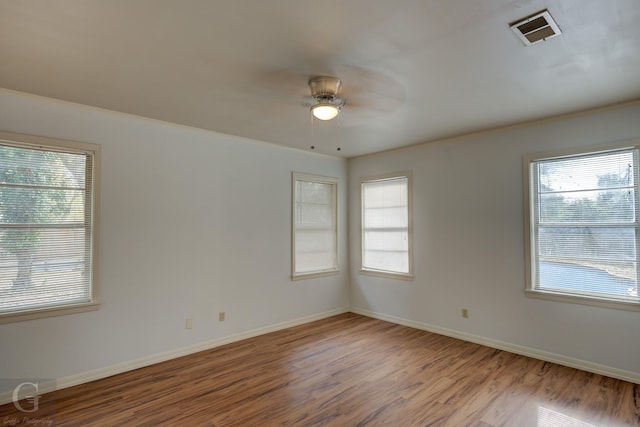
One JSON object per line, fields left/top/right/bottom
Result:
{"left": 0, "top": 131, "right": 102, "bottom": 324}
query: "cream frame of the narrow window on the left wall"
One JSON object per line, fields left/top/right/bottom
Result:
{"left": 291, "top": 172, "right": 340, "bottom": 280}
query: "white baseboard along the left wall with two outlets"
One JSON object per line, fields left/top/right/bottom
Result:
{"left": 0, "top": 308, "right": 349, "bottom": 405}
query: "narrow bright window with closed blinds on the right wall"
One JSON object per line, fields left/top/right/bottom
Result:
{"left": 361, "top": 174, "right": 413, "bottom": 278}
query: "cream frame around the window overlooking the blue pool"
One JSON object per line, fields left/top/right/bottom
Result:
{"left": 522, "top": 141, "right": 640, "bottom": 311}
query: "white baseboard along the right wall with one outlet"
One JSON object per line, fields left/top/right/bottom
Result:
{"left": 349, "top": 307, "right": 640, "bottom": 384}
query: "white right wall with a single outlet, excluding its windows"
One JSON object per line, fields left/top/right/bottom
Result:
{"left": 349, "top": 103, "right": 640, "bottom": 381}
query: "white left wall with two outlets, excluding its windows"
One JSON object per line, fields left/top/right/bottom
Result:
{"left": 0, "top": 91, "right": 348, "bottom": 392}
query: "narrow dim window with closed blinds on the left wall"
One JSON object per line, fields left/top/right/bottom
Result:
{"left": 291, "top": 173, "right": 338, "bottom": 279}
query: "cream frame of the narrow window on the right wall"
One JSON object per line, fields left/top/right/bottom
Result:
{"left": 359, "top": 171, "right": 414, "bottom": 281}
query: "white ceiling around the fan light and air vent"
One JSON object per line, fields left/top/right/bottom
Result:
{"left": 0, "top": 0, "right": 640, "bottom": 157}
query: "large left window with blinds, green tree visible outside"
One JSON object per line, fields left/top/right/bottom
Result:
{"left": 0, "top": 133, "right": 100, "bottom": 322}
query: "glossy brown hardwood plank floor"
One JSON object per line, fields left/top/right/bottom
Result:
{"left": 0, "top": 313, "right": 640, "bottom": 427}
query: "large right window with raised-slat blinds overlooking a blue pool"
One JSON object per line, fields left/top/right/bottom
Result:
{"left": 524, "top": 147, "right": 640, "bottom": 309}
